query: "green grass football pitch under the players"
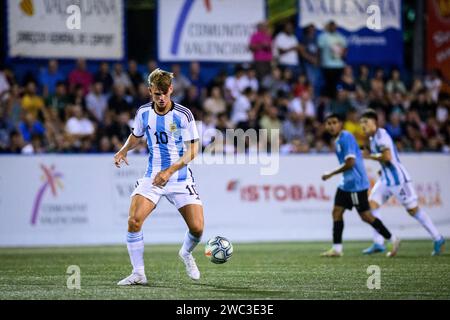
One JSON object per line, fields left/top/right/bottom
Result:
{"left": 0, "top": 240, "right": 450, "bottom": 299}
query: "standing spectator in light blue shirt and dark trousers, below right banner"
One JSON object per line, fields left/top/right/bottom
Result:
{"left": 318, "top": 21, "right": 347, "bottom": 98}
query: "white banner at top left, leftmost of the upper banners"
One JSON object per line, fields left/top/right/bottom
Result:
{"left": 7, "top": 0, "right": 124, "bottom": 59}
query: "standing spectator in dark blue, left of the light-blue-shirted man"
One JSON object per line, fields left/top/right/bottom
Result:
{"left": 299, "top": 24, "right": 322, "bottom": 97}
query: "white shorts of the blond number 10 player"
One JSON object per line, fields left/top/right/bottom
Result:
{"left": 130, "top": 178, "right": 202, "bottom": 209}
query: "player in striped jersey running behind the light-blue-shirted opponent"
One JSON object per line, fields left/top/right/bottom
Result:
{"left": 360, "top": 109, "right": 445, "bottom": 256}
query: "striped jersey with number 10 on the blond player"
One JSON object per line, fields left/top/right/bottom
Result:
{"left": 131, "top": 101, "right": 199, "bottom": 182}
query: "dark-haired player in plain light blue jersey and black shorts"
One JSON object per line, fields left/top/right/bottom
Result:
{"left": 321, "top": 114, "right": 400, "bottom": 257}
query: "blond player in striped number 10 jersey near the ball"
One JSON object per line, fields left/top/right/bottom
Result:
{"left": 114, "top": 69, "right": 203, "bottom": 285}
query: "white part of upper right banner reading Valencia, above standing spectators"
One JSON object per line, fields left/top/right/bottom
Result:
{"left": 299, "top": 0, "right": 401, "bottom": 31}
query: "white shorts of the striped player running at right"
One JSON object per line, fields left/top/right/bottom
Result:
{"left": 369, "top": 180, "right": 418, "bottom": 210}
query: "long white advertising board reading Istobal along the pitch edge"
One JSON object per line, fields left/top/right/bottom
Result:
{"left": 0, "top": 154, "right": 450, "bottom": 246}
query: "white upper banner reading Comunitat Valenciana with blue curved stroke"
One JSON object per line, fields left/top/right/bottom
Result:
{"left": 158, "top": 0, "right": 266, "bottom": 62}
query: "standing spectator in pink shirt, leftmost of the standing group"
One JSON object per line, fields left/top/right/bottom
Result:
{"left": 249, "top": 21, "right": 273, "bottom": 81}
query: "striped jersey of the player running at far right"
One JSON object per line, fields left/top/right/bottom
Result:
{"left": 370, "top": 128, "right": 411, "bottom": 186}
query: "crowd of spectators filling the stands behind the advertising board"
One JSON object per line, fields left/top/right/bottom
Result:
{"left": 0, "top": 22, "right": 450, "bottom": 154}
